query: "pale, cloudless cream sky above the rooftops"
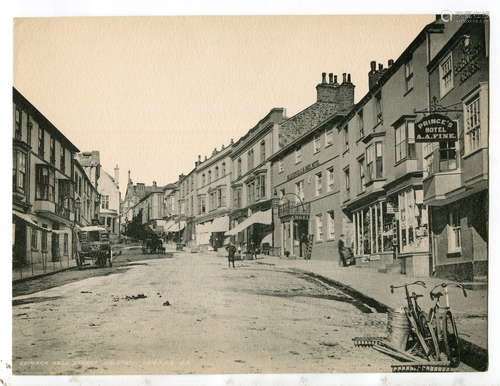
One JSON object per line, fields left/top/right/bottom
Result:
{"left": 14, "top": 15, "right": 434, "bottom": 195}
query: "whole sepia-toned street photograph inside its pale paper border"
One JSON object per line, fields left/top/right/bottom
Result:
{"left": 12, "top": 14, "right": 489, "bottom": 375}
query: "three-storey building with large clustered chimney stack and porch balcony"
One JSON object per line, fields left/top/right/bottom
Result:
{"left": 271, "top": 73, "right": 354, "bottom": 259}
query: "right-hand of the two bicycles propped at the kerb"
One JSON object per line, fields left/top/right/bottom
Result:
{"left": 427, "top": 282, "right": 467, "bottom": 367}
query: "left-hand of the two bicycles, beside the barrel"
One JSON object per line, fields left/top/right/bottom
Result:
{"left": 390, "top": 280, "right": 438, "bottom": 360}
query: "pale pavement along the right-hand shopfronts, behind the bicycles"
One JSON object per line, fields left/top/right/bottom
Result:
{"left": 262, "top": 256, "right": 488, "bottom": 369}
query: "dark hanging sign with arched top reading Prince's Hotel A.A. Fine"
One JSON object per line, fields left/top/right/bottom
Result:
{"left": 415, "top": 114, "right": 457, "bottom": 142}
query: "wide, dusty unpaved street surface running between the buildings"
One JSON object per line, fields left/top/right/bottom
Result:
{"left": 13, "top": 250, "right": 468, "bottom": 375}
